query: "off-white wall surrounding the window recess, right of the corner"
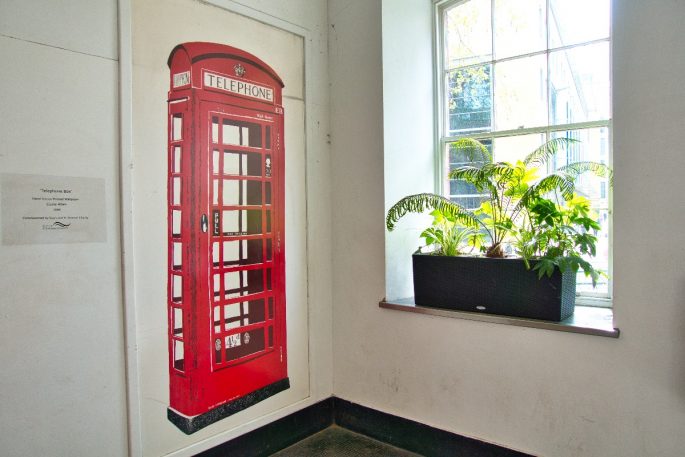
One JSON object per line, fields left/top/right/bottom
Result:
{"left": 329, "top": 0, "right": 685, "bottom": 457}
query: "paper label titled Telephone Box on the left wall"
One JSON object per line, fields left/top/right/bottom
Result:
{"left": 0, "top": 174, "right": 107, "bottom": 245}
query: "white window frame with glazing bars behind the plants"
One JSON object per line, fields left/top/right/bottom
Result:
{"left": 433, "top": 0, "right": 613, "bottom": 308}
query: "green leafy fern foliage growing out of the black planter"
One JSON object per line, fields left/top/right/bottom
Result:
{"left": 386, "top": 138, "right": 613, "bottom": 284}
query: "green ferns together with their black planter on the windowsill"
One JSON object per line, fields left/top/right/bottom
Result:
{"left": 386, "top": 138, "right": 613, "bottom": 321}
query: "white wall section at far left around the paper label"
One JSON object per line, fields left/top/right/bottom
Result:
{"left": 0, "top": 0, "right": 127, "bottom": 456}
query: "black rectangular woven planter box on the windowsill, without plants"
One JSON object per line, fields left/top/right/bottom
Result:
{"left": 412, "top": 253, "right": 576, "bottom": 322}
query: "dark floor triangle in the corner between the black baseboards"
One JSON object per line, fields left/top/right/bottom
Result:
{"left": 272, "top": 425, "right": 419, "bottom": 457}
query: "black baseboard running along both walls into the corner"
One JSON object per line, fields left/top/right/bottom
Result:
{"left": 198, "top": 397, "right": 531, "bottom": 457}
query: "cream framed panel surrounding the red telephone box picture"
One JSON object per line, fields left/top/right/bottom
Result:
{"left": 120, "top": 0, "right": 332, "bottom": 455}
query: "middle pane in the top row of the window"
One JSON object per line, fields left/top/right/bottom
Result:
{"left": 495, "top": 0, "right": 547, "bottom": 59}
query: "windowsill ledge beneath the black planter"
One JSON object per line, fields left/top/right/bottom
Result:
{"left": 379, "top": 298, "right": 621, "bottom": 338}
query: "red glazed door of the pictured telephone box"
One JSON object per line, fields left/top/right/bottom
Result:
{"left": 201, "top": 103, "right": 285, "bottom": 384}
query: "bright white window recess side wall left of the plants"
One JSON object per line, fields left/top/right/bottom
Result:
{"left": 382, "top": 0, "right": 436, "bottom": 300}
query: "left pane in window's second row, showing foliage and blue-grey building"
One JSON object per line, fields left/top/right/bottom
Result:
{"left": 447, "top": 64, "right": 492, "bottom": 135}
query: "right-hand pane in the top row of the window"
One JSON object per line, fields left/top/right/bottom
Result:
{"left": 549, "top": 0, "right": 610, "bottom": 48}
